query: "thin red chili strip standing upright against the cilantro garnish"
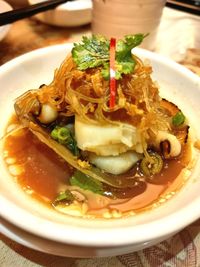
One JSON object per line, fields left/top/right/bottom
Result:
{"left": 110, "top": 38, "right": 116, "bottom": 109}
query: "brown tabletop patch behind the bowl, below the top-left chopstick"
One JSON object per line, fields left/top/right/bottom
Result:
{"left": 0, "top": 19, "right": 90, "bottom": 65}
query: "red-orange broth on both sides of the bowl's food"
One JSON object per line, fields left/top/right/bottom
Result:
{"left": 4, "top": 117, "right": 190, "bottom": 217}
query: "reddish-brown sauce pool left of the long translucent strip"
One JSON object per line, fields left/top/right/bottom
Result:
{"left": 5, "top": 130, "right": 72, "bottom": 200}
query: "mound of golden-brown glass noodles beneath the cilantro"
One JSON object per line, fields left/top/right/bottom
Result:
{"left": 14, "top": 55, "right": 170, "bottom": 153}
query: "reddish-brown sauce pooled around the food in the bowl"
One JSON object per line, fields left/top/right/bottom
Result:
{"left": 4, "top": 116, "right": 190, "bottom": 217}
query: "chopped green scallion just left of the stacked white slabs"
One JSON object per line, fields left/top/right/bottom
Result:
{"left": 51, "top": 126, "right": 79, "bottom": 156}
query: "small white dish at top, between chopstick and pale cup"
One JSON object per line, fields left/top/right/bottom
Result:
{"left": 29, "top": 0, "right": 92, "bottom": 27}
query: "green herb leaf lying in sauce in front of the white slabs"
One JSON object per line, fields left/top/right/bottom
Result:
{"left": 70, "top": 170, "right": 104, "bottom": 195}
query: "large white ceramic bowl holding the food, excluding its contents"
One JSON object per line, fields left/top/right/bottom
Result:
{"left": 0, "top": 44, "right": 200, "bottom": 257}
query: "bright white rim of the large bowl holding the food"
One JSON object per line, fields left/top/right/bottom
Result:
{"left": 0, "top": 43, "right": 200, "bottom": 247}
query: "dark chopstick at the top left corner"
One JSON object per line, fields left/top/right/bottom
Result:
{"left": 0, "top": 0, "right": 73, "bottom": 26}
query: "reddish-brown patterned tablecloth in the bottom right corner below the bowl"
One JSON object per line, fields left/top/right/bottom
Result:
{"left": 118, "top": 220, "right": 200, "bottom": 267}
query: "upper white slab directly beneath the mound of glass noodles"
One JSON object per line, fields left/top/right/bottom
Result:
{"left": 75, "top": 116, "right": 143, "bottom": 156}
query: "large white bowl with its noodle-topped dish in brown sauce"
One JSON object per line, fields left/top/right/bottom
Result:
{"left": 0, "top": 37, "right": 200, "bottom": 256}
